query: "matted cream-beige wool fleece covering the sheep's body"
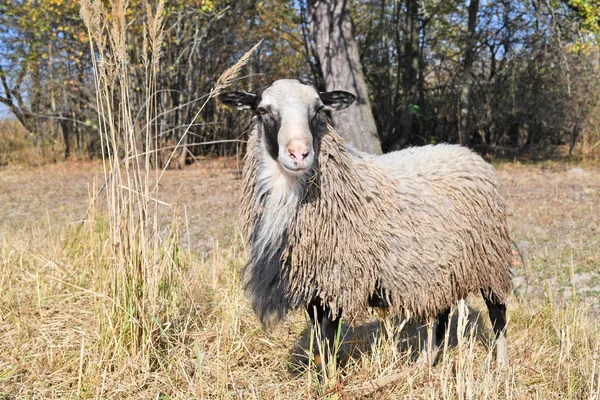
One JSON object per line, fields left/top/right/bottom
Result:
{"left": 242, "top": 127, "right": 512, "bottom": 324}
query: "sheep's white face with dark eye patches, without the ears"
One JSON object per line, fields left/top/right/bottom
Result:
{"left": 256, "top": 79, "right": 324, "bottom": 175}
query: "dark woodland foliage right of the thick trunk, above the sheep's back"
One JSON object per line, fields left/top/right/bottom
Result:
{"left": 355, "top": 1, "right": 600, "bottom": 152}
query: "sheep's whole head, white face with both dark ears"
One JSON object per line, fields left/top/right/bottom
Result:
{"left": 219, "top": 79, "right": 356, "bottom": 176}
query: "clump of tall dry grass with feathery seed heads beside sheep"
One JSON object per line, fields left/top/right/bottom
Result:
{"left": 80, "top": 0, "right": 258, "bottom": 371}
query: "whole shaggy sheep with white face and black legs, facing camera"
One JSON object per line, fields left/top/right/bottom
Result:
{"left": 220, "top": 79, "right": 512, "bottom": 369}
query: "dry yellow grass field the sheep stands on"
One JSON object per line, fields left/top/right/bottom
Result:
{"left": 0, "top": 158, "right": 600, "bottom": 399}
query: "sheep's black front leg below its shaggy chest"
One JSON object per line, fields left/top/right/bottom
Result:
{"left": 308, "top": 299, "right": 341, "bottom": 379}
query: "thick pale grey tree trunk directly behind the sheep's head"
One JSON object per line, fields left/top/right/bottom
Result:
{"left": 308, "top": 0, "right": 381, "bottom": 154}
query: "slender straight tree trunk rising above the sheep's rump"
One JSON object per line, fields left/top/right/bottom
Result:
{"left": 458, "top": 0, "right": 479, "bottom": 146}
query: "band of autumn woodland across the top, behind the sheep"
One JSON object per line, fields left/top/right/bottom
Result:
{"left": 0, "top": 0, "right": 600, "bottom": 165}
